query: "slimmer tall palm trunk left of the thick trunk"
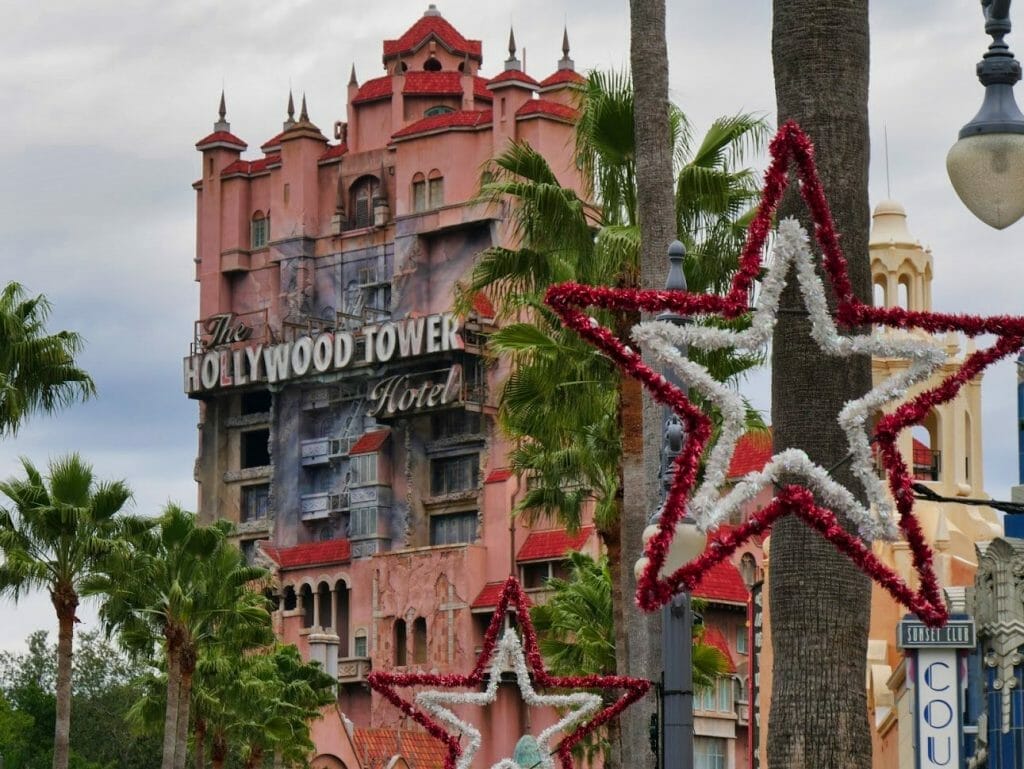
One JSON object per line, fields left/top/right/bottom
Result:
{"left": 622, "top": 0, "right": 676, "bottom": 767}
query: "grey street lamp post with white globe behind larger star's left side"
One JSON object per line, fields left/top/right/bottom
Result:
{"left": 637, "top": 241, "right": 706, "bottom": 769}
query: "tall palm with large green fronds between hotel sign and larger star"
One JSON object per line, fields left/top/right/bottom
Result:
{"left": 464, "top": 73, "right": 766, "bottom": 708}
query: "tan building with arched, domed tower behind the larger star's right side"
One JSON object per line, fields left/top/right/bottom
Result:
{"left": 867, "top": 201, "right": 1002, "bottom": 769}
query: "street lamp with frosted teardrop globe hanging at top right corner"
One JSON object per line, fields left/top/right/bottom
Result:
{"left": 946, "top": 0, "right": 1024, "bottom": 229}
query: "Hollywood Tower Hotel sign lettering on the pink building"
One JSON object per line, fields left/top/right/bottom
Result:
{"left": 183, "top": 312, "right": 463, "bottom": 397}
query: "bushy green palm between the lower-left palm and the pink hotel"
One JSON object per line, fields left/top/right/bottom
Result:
{"left": 86, "top": 504, "right": 271, "bottom": 769}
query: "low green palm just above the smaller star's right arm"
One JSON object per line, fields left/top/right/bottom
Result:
{"left": 529, "top": 552, "right": 729, "bottom": 765}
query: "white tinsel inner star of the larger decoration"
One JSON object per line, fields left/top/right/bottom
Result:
{"left": 633, "top": 219, "right": 946, "bottom": 541}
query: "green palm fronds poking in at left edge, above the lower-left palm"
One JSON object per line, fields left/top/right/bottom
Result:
{"left": 0, "top": 283, "right": 96, "bottom": 435}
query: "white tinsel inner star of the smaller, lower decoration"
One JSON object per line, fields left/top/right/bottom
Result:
{"left": 416, "top": 629, "right": 602, "bottom": 769}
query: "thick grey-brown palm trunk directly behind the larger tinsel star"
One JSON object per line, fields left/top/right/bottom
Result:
{"left": 768, "top": 0, "right": 871, "bottom": 769}
